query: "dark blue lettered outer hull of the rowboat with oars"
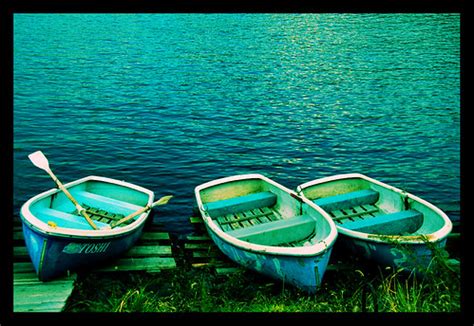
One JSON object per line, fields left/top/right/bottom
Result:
{"left": 23, "top": 223, "right": 144, "bottom": 281}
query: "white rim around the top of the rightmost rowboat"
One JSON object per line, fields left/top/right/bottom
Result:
{"left": 296, "top": 173, "right": 453, "bottom": 244}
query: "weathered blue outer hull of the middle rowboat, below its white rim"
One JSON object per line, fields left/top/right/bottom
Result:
{"left": 207, "top": 228, "right": 332, "bottom": 293}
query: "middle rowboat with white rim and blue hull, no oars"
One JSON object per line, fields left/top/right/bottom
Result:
{"left": 195, "top": 174, "right": 337, "bottom": 292}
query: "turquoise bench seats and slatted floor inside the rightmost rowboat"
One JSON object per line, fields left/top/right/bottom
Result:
{"left": 313, "top": 189, "right": 423, "bottom": 235}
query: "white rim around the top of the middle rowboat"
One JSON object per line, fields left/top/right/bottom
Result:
{"left": 194, "top": 173, "right": 337, "bottom": 257}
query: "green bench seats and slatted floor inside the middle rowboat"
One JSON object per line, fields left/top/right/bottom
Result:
{"left": 204, "top": 191, "right": 316, "bottom": 247}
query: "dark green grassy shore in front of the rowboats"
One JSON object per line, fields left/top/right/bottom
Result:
{"left": 64, "top": 243, "right": 461, "bottom": 313}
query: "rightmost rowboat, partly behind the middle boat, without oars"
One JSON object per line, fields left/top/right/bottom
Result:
{"left": 296, "top": 173, "right": 452, "bottom": 271}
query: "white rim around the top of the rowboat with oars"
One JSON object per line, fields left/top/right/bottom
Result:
{"left": 20, "top": 175, "right": 155, "bottom": 239}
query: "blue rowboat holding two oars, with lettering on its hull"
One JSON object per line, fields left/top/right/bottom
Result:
{"left": 20, "top": 152, "right": 171, "bottom": 281}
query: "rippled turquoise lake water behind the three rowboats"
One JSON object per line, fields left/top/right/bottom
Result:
{"left": 13, "top": 14, "right": 461, "bottom": 234}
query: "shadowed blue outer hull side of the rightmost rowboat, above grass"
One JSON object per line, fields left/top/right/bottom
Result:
{"left": 339, "top": 234, "right": 446, "bottom": 271}
